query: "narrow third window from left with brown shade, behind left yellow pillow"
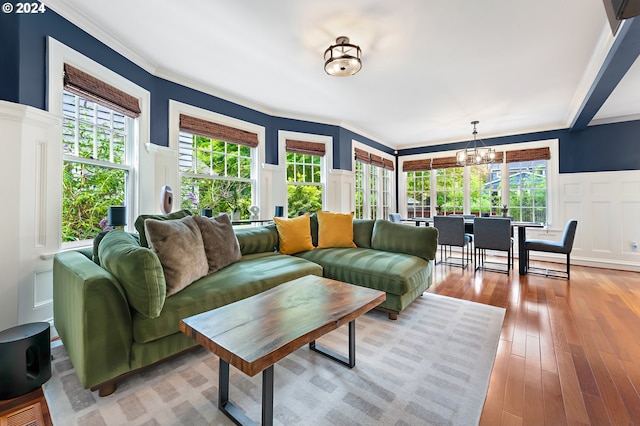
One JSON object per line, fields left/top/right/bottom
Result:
{"left": 286, "top": 139, "right": 325, "bottom": 217}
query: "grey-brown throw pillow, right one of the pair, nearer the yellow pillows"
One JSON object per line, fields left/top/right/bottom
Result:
{"left": 193, "top": 214, "right": 242, "bottom": 273}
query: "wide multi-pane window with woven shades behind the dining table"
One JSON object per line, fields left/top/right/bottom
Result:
{"left": 403, "top": 147, "right": 551, "bottom": 222}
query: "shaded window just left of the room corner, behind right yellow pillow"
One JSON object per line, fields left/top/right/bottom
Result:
{"left": 354, "top": 147, "right": 394, "bottom": 219}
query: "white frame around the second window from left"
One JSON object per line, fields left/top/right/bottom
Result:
{"left": 169, "top": 100, "right": 265, "bottom": 215}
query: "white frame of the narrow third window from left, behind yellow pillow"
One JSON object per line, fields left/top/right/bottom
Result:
{"left": 278, "top": 130, "right": 333, "bottom": 217}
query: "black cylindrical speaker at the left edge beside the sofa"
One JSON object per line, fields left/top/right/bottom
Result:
{"left": 0, "top": 322, "right": 51, "bottom": 399}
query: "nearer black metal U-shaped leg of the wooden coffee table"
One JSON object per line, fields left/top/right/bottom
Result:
{"left": 218, "top": 359, "right": 273, "bottom": 426}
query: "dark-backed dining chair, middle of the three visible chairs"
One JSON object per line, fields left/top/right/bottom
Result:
{"left": 473, "top": 217, "right": 513, "bottom": 274}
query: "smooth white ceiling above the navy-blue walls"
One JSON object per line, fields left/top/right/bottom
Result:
{"left": 44, "top": 0, "right": 640, "bottom": 149}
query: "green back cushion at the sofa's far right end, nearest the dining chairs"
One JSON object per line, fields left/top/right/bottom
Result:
{"left": 371, "top": 219, "right": 438, "bottom": 260}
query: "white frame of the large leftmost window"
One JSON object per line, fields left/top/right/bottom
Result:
{"left": 47, "top": 37, "right": 151, "bottom": 249}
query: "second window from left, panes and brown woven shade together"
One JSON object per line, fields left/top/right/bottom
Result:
{"left": 178, "top": 114, "right": 259, "bottom": 220}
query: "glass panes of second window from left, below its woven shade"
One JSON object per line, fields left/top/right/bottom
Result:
{"left": 178, "top": 131, "right": 255, "bottom": 220}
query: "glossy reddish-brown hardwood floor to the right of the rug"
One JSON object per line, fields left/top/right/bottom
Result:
{"left": 428, "top": 260, "right": 640, "bottom": 425}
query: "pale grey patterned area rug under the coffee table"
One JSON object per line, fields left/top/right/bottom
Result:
{"left": 44, "top": 293, "right": 504, "bottom": 426}
